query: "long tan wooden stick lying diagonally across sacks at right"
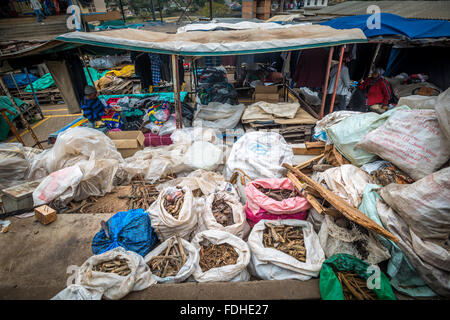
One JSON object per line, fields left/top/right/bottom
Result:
{"left": 283, "top": 163, "right": 398, "bottom": 242}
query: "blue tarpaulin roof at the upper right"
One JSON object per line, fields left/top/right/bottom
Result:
{"left": 320, "top": 13, "right": 450, "bottom": 39}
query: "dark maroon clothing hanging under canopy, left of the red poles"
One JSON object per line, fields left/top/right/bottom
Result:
{"left": 293, "top": 48, "right": 328, "bottom": 88}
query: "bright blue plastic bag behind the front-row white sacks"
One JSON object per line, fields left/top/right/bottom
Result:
{"left": 92, "top": 209, "right": 158, "bottom": 256}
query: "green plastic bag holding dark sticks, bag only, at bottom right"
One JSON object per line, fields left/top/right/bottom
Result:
{"left": 319, "top": 254, "right": 396, "bottom": 300}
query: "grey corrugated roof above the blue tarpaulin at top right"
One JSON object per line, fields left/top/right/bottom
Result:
{"left": 316, "top": 1, "right": 450, "bottom": 20}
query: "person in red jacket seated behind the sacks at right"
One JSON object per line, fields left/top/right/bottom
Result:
{"left": 358, "top": 68, "right": 392, "bottom": 109}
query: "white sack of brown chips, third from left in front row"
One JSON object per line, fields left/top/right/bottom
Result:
{"left": 191, "top": 230, "right": 250, "bottom": 282}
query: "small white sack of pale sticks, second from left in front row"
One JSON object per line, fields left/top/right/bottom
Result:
{"left": 144, "top": 236, "right": 199, "bottom": 283}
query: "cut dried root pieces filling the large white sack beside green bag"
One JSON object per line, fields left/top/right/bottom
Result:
{"left": 263, "top": 223, "right": 306, "bottom": 262}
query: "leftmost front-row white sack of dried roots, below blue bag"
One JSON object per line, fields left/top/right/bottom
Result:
{"left": 71, "top": 247, "right": 156, "bottom": 300}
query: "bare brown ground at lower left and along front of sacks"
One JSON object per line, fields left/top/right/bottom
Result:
{"left": 0, "top": 214, "right": 320, "bottom": 300}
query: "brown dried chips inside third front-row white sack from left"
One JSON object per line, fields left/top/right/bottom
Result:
{"left": 200, "top": 240, "right": 239, "bottom": 272}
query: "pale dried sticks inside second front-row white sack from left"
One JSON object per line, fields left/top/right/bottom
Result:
{"left": 147, "top": 236, "right": 187, "bottom": 278}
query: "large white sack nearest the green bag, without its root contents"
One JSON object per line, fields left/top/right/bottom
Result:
{"left": 248, "top": 219, "right": 325, "bottom": 280}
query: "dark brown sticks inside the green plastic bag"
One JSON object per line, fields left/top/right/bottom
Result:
{"left": 336, "top": 271, "right": 378, "bottom": 300}
